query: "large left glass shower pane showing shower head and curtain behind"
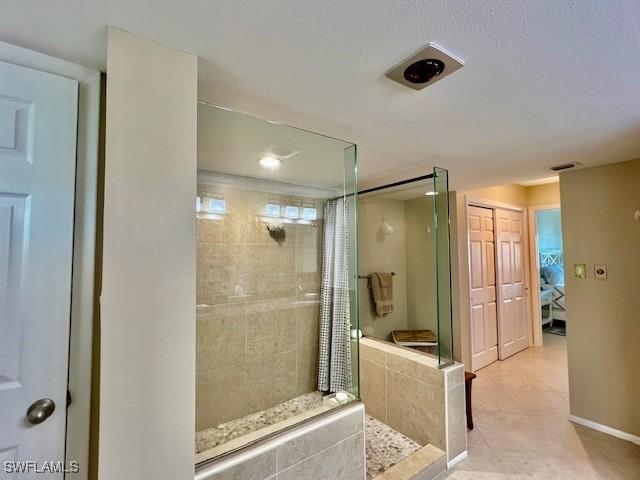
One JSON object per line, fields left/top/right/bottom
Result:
{"left": 194, "top": 103, "right": 360, "bottom": 463}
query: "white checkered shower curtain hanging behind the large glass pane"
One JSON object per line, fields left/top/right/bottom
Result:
{"left": 318, "top": 198, "right": 353, "bottom": 393}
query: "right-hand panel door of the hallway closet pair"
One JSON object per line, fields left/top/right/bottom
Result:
{"left": 495, "top": 209, "right": 529, "bottom": 360}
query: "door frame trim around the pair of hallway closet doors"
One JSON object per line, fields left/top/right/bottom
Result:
{"left": 458, "top": 194, "right": 539, "bottom": 372}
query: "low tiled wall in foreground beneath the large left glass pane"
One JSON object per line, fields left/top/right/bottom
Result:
{"left": 195, "top": 402, "right": 365, "bottom": 480}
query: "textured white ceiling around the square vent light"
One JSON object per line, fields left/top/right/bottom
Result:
{"left": 0, "top": 0, "right": 640, "bottom": 188}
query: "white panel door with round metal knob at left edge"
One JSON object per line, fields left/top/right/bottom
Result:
{"left": 0, "top": 62, "right": 78, "bottom": 479}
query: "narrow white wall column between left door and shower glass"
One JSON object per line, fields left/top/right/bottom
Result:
{"left": 99, "top": 29, "right": 197, "bottom": 480}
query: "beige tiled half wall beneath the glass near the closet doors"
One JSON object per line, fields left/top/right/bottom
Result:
{"left": 360, "top": 338, "right": 466, "bottom": 460}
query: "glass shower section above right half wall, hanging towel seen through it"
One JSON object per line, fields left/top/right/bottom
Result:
{"left": 358, "top": 167, "right": 454, "bottom": 367}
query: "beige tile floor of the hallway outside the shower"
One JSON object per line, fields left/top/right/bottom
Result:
{"left": 439, "top": 334, "right": 640, "bottom": 480}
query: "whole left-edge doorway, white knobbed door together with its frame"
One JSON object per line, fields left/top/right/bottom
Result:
{"left": 0, "top": 42, "right": 101, "bottom": 479}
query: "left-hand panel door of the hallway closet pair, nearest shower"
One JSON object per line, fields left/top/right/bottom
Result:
{"left": 467, "top": 206, "right": 498, "bottom": 371}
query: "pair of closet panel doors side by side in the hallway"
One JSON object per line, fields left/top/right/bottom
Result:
{"left": 467, "top": 202, "right": 530, "bottom": 371}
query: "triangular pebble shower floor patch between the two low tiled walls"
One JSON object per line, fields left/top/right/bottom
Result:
{"left": 365, "top": 415, "right": 422, "bottom": 480}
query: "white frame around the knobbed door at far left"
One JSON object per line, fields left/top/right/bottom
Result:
{"left": 0, "top": 42, "right": 102, "bottom": 480}
